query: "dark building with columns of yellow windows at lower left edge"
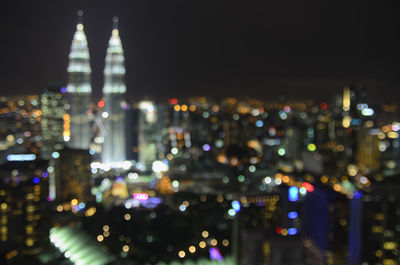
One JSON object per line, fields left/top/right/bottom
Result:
{"left": 0, "top": 158, "right": 49, "bottom": 264}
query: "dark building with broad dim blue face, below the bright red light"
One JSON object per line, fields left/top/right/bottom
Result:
{"left": 302, "top": 188, "right": 350, "bottom": 265}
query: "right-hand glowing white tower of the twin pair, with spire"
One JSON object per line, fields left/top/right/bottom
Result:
{"left": 102, "top": 17, "right": 126, "bottom": 166}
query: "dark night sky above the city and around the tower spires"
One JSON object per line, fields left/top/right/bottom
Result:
{"left": 0, "top": 0, "right": 400, "bottom": 102}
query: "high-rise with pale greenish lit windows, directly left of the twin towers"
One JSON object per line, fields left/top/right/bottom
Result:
{"left": 40, "top": 86, "right": 65, "bottom": 159}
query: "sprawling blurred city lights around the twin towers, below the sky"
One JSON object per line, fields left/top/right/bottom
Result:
{"left": 0, "top": 85, "right": 400, "bottom": 265}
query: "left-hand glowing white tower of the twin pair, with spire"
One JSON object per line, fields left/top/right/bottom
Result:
{"left": 64, "top": 11, "right": 92, "bottom": 149}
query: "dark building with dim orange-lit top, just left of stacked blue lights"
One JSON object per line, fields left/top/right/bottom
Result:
{"left": 238, "top": 192, "right": 304, "bottom": 265}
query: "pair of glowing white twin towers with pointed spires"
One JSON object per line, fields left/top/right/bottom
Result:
{"left": 64, "top": 11, "right": 126, "bottom": 167}
